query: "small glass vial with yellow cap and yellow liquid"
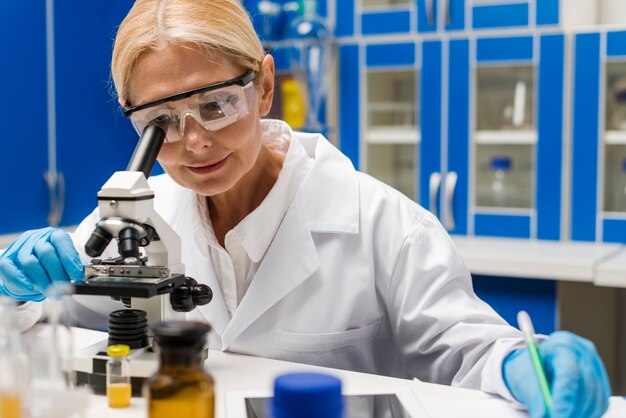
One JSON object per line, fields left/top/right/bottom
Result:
{"left": 107, "top": 344, "right": 132, "bottom": 408}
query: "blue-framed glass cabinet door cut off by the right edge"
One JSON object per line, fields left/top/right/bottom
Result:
{"left": 571, "top": 31, "right": 626, "bottom": 243}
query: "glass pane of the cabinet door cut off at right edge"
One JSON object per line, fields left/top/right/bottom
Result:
{"left": 604, "top": 62, "right": 626, "bottom": 212}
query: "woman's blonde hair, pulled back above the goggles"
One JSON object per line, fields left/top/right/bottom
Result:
{"left": 111, "top": 0, "right": 264, "bottom": 104}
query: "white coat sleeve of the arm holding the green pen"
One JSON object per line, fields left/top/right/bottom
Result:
{"left": 388, "top": 213, "right": 523, "bottom": 399}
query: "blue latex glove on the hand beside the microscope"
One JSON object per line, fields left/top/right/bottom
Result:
{"left": 0, "top": 228, "right": 83, "bottom": 302}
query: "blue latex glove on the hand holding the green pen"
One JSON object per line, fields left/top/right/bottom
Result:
{"left": 502, "top": 331, "right": 611, "bottom": 418}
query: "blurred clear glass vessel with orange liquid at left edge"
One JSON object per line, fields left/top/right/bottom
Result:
{"left": 0, "top": 296, "right": 28, "bottom": 418}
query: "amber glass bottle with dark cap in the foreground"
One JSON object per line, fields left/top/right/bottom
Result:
{"left": 145, "top": 321, "right": 215, "bottom": 418}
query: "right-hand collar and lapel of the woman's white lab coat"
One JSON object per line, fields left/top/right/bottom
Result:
{"left": 222, "top": 126, "right": 359, "bottom": 350}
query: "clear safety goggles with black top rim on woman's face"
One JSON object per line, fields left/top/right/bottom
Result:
{"left": 124, "top": 71, "right": 256, "bottom": 142}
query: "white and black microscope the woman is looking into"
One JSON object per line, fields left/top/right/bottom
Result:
{"left": 72, "top": 125, "right": 213, "bottom": 395}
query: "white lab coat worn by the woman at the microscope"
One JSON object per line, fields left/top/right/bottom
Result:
{"left": 61, "top": 127, "right": 522, "bottom": 397}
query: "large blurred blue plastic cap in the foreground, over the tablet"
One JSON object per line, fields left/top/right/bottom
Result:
{"left": 271, "top": 373, "right": 343, "bottom": 418}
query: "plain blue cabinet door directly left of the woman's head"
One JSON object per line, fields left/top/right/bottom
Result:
{"left": 55, "top": 0, "right": 137, "bottom": 229}
